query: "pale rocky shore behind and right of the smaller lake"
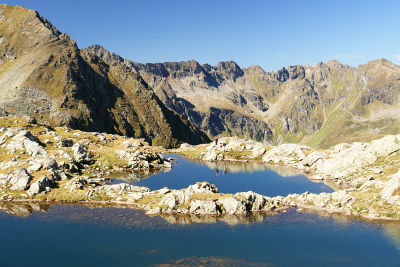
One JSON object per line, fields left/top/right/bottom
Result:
{"left": 175, "top": 135, "right": 400, "bottom": 219}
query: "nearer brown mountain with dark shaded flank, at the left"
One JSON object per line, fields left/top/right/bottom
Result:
{"left": 0, "top": 5, "right": 209, "bottom": 147}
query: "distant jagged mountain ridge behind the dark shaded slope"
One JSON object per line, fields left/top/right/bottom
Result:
{"left": 86, "top": 45, "right": 400, "bottom": 147}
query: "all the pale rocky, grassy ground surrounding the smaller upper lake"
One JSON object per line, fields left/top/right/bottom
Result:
{"left": 0, "top": 117, "right": 400, "bottom": 221}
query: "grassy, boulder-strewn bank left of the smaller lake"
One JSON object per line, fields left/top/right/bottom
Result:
{"left": 0, "top": 117, "right": 172, "bottom": 201}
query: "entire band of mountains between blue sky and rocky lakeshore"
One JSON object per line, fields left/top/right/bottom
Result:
{"left": 0, "top": 5, "right": 400, "bottom": 147}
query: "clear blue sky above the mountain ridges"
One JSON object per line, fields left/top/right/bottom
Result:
{"left": 3, "top": 0, "right": 400, "bottom": 71}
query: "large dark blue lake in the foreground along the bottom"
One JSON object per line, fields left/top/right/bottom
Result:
{"left": 0, "top": 203, "right": 400, "bottom": 266}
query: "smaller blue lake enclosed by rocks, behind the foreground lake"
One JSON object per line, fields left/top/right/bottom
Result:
{"left": 122, "top": 155, "right": 334, "bottom": 197}
